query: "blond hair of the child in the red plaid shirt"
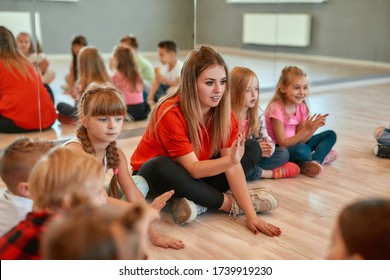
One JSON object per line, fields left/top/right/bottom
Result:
{"left": 28, "top": 147, "right": 104, "bottom": 211}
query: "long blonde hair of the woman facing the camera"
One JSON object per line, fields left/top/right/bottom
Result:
{"left": 150, "top": 46, "right": 231, "bottom": 155}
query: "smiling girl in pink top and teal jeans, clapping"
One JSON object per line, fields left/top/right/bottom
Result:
{"left": 265, "top": 66, "right": 338, "bottom": 177}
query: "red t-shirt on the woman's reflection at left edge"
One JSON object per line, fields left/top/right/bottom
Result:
{"left": 0, "top": 61, "right": 57, "bottom": 129}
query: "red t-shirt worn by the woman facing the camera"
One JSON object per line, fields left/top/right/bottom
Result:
{"left": 130, "top": 97, "right": 238, "bottom": 170}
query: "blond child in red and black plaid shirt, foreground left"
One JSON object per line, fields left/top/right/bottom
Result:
{"left": 0, "top": 147, "right": 107, "bottom": 260}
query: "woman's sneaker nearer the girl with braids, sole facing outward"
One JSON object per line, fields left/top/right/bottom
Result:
{"left": 171, "top": 197, "right": 207, "bottom": 225}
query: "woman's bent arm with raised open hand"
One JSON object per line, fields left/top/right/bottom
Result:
{"left": 176, "top": 134, "right": 245, "bottom": 179}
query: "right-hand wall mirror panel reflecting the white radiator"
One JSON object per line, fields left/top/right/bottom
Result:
{"left": 197, "top": 0, "right": 390, "bottom": 90}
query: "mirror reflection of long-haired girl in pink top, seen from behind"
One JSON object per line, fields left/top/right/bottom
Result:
{"left": 111, "top": 46, "right": 150, "bottom": 121}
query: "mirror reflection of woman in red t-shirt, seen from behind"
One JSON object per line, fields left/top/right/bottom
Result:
{"left": 0, "top": 26, "right": 57, "bottom": 133}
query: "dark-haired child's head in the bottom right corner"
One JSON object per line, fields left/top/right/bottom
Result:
{"left": 328, "top": 198, "right": 390, "bottom": 260}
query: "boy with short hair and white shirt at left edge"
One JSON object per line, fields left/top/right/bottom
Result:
{"left": 0, "top": 137, "right": 54, "bottom": 236}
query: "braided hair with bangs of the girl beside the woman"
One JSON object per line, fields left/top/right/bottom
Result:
{"left": 77, "top": 83, "right": 127, "bottom": 198}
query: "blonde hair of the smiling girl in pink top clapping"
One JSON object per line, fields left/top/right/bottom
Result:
{"left": 268, "top": 66, "right": 309, "bottom": 117}
